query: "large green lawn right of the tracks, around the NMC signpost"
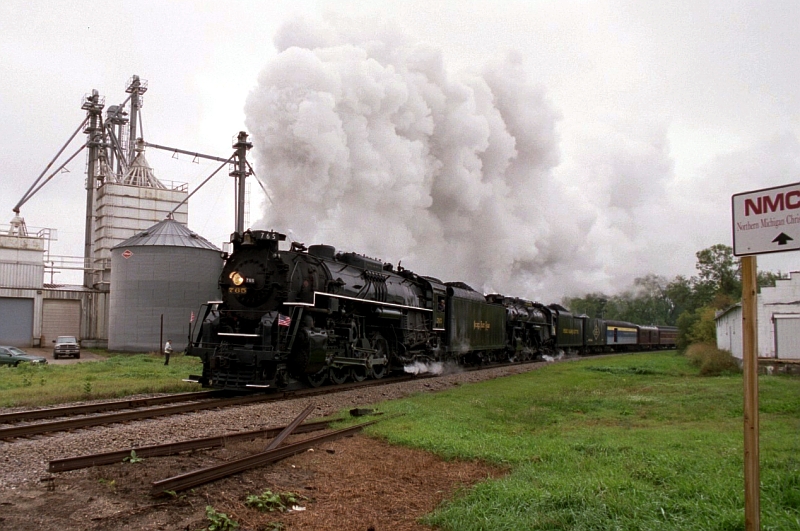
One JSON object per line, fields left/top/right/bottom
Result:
{"left": 358, "top": 353, "right": 800, "bottom": 531}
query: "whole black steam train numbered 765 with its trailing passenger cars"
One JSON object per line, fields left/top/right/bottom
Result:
{"left": 186, "top": 230, "right": 677, "bottom": 391}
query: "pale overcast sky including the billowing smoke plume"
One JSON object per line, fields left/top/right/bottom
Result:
{"left": 0, "top": 0, "right": 800, "bottom": 302}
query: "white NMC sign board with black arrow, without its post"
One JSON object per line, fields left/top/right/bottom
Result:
{"left": 731, "top": 183, "right": 800, "bottom": 256}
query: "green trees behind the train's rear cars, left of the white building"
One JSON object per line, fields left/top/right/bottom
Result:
{"left": 562, "top": 244, "right": 781, "bottom": 349}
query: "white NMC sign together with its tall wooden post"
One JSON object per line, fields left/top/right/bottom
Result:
{"left": 731, "top": 183, "right": 800, "bottom": 531}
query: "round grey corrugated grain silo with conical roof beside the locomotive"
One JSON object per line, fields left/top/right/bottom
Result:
{"left": 108, "top": 219, "right": 222, "bottom": 352}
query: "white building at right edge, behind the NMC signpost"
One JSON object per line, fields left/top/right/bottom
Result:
{"left": 716, "top": 271, "right": 800, "bottom": 360}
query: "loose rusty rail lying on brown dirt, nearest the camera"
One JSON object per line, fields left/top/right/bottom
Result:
{"left": 155, "top": 420, "right": 386, "bottom": 496}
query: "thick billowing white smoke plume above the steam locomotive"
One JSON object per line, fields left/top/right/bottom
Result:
{"left": 245, "top": 14, "right": 648, "bottom": 302}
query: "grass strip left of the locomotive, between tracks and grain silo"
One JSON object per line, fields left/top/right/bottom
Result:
{"left": 0, "top": 354, "right": 202, "bottom": 407}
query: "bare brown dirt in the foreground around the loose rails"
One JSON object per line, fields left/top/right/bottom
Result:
{"left": 0, "top": 435, "right": 502, "bottom": 531}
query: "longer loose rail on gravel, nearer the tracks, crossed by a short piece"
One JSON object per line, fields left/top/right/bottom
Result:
{"left": 47, "top": 420, "right": 335, "bottom": 472}
